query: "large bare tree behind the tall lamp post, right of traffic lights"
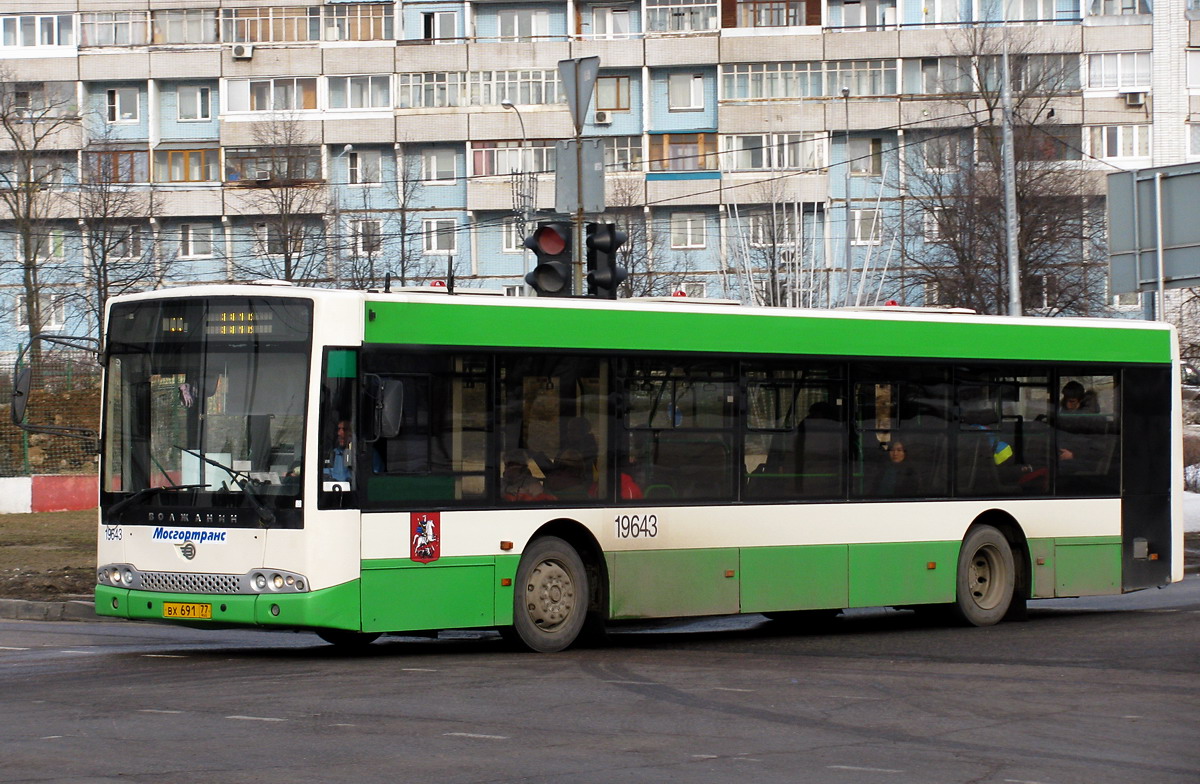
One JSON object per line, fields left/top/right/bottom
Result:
{"left": 896, "top": 28, "right": 1104, "bottom": 315}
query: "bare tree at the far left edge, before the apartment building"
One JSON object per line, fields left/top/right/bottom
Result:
{"left": 0, "top": 66, "right": 80, "bottom": 343}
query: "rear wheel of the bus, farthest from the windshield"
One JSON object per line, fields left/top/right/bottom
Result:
{"left": 954, "top": 526, "right": 1016, "bottom": 626}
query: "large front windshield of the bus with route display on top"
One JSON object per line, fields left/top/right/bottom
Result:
{"left": 102, "top": 298, "right": 312, "bottom": 527}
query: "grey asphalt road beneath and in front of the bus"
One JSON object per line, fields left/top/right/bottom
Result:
{"left": 0, "top": 579, "right": 1200, "bottom": 784}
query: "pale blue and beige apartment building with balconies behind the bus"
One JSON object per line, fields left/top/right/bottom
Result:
{"left": 0, "top": 0, "right": 1200, "bottom": 345}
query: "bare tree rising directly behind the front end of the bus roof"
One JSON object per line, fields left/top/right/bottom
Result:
{"left": 226, "top": 113, "right": 335, "bottom": 282}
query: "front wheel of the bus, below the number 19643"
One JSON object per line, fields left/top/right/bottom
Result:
{"left": 504, "top": 537, "right": 588, "bottom": 653}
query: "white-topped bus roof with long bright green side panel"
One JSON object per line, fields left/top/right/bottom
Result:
{"left": 112, "top": 285, "right": 1175, "bottom": 363}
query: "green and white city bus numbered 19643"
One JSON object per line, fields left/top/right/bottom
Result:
{"left": 82, "top": 285, "right": 1183, "bottom": 651}
